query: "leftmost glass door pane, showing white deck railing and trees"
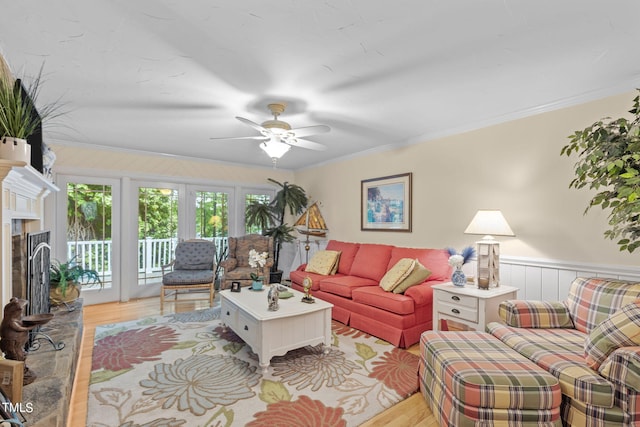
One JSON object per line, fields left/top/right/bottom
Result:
{"left": 67, "top": 183, "right": 113, "bottom": 292}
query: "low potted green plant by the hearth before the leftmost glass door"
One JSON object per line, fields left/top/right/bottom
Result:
{"left": 49, "top": 257, "right": 103, "bottom": 305}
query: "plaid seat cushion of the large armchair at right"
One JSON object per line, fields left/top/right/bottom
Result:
{"left": 487, "top": 322, "right": 614, "bottom": 408}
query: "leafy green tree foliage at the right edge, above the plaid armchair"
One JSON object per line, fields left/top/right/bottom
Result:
{"left": 561, "top": 90, "right": 640, "bottom": 252}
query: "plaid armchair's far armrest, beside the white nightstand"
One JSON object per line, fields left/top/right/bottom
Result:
{"left": 498, "top": 300, "right": 574, "bottom": 328}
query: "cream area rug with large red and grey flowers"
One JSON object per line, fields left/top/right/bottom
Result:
{"left": 87, "top": 307, "right": 418, "bottom": 427}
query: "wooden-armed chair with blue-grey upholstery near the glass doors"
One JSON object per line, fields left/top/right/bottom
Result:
{"left": 160, "top": 239, "right": 216, "bottom": 311}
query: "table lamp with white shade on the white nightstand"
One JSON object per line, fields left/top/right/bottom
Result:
{"left": 464, "top": 210, "right": 515, "bottom": 289}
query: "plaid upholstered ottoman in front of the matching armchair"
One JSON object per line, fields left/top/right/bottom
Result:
{"left": 419, "top": 331, "right": 562, "bottom": 427}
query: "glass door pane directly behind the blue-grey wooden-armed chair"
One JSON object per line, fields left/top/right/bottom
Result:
{"left": 138, "top": 187, "right": 178, "bottom": 285}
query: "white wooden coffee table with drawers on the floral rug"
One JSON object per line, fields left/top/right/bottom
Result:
{"left": 220, "top": 286, "right": 333, "bottom": 372}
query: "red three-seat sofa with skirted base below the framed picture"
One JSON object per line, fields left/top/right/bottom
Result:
{"left": 290, "top": 240, "right": 451, "bottom": 348}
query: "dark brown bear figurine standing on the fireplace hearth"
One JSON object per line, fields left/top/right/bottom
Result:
{"left": 0, "top": 297, "right": 36, "bottom": 385}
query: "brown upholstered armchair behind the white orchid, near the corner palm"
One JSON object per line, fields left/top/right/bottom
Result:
{"left": 220, "top": 234, "right": 274, "bottom": 289}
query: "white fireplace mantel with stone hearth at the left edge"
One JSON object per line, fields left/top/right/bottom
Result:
{"left": 0, "top": 159, "right": 82, "bottom": 427}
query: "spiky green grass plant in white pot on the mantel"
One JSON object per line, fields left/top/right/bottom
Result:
{"left": 0, "top": 65, "right": 62, "bottom": 164}
